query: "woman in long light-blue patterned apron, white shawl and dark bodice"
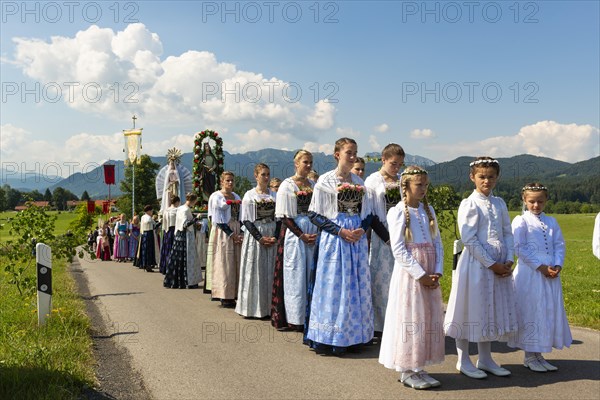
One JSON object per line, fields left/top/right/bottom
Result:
{"left": 305, "top": 138, "right": 373, "bottom": 354}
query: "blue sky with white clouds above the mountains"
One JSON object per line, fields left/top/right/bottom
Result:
{"left": 0, "top": 1, "right": 600, "bottom": 175}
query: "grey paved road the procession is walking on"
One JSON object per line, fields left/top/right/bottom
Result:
{"left": 75, "top": 255, "right": 600, "bottom": 399}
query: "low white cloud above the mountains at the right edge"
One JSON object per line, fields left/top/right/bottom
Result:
{"left": 434, "top": 121, "right": 600, "bottom": 163}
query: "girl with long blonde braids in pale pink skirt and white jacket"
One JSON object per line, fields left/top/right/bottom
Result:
{"left": 379, "top": 166, "right": 444, "bottom": 389}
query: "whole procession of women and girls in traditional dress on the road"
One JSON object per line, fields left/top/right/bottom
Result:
{"left": 97, "top": 138, "right": 572, "bottom": 389}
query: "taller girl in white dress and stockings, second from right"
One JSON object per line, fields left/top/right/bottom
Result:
{"left": 444, "top": 157, "right": 517, "bottom": 379}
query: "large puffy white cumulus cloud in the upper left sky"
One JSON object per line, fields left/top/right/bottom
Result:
{"left": 11, "top": 23, "right": 335, "bottom": 140}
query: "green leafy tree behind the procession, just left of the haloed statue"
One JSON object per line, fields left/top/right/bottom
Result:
{"left": 117, "top": 154, "right": 160, "bottom": 215}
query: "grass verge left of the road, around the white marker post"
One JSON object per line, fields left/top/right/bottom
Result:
{"left": 0, "top": 212, "right": 95, "bottom": 399}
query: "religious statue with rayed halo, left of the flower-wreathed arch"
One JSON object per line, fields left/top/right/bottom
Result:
{"left": 156, "top": 147, "right": 192, "bottom": 215}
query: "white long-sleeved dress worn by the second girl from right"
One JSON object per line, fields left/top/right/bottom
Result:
{"left": 444, "top": 190, "right": 517, "bottom": 342}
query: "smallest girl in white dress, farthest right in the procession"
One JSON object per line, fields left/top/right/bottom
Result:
{"left": 508, "top": 182, "right": 573, "bottom": 372}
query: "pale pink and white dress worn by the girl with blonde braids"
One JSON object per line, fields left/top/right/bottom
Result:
{"left": 379, "top": 202, "right": 444, "bottom": 371}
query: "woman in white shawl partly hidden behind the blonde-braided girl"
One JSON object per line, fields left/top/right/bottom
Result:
{"left": 364, "top": 143, "right": 405, "bottom": 337}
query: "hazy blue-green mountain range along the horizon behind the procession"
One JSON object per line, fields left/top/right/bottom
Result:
{"left": 1, "top": 149, "right": 600, "bottom": 199}
